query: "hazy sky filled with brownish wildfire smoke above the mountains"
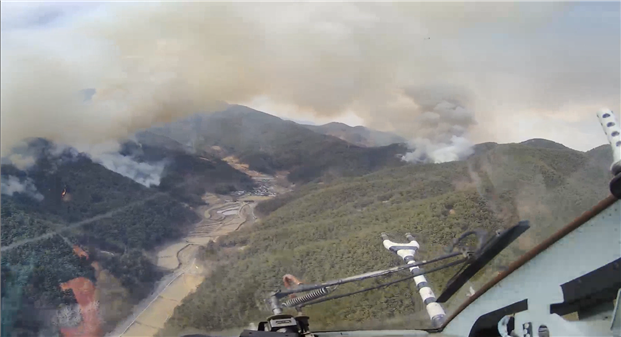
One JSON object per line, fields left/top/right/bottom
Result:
{"left": 2, "top": 2, "right": 621, "bottom": 150}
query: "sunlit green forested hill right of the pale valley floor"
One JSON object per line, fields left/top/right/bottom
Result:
{"left": 160, "top": 143, "right": 611, "bottom": 336}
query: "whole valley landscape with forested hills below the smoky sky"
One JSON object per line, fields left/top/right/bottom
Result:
{"left": 2, "top": 106, "right": 610, "bottom": 337}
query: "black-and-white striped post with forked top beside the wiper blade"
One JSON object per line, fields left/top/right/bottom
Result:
{"left": 382, "top": 233, "right": 446, "bottom": 328}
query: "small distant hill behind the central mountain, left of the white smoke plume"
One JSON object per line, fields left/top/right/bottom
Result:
{"left": 304, "top": 122, "right": 406, "bottom": 147}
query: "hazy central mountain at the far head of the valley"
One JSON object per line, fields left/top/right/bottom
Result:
{"left": 148, "top": 105, "right": 406, "bottom": 183}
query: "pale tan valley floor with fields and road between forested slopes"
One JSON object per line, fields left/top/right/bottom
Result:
{"left": 111, "top": 174, "right": 283, "bottom": 337}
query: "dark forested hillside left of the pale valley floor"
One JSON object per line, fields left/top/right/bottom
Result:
{"left": 1, "top": 140, "right": 203, "bottom": 336}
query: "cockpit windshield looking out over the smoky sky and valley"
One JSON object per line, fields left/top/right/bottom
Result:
{"left": 1, "top": 2, "right": 621, "bottom": 337}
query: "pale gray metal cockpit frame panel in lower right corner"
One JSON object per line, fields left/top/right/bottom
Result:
{"left": 443, "top": 201, "right": 621, "bottom": 336}
